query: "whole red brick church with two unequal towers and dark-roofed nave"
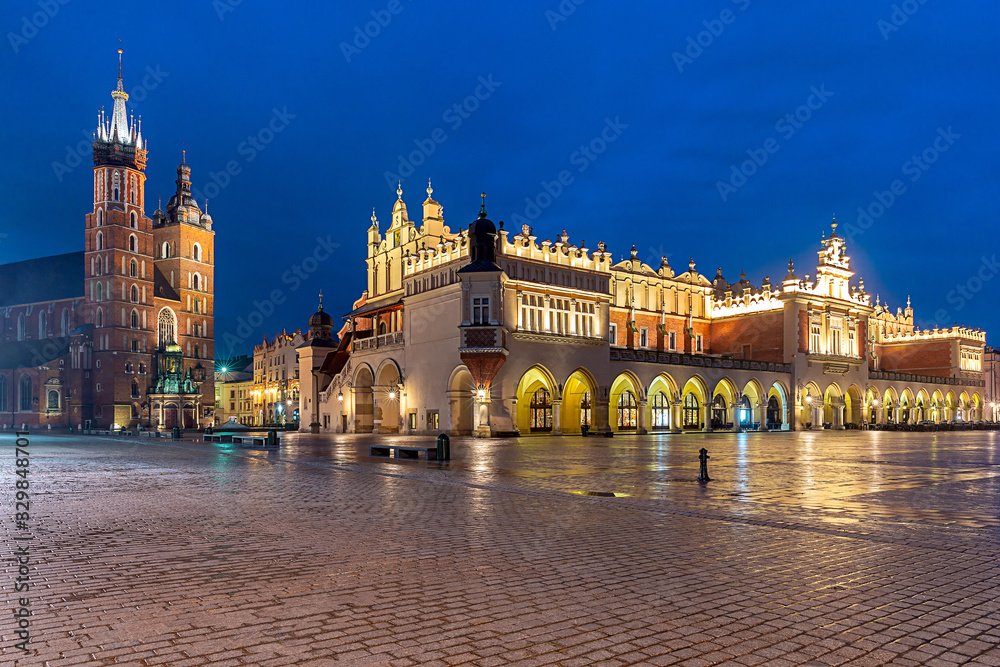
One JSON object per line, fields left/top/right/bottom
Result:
{"left": 0, "top": 57, "right": 215, "bottom": 429}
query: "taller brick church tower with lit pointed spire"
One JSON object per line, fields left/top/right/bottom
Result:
{"left": 83, "top": 49, "right": 156, "bottom": 427}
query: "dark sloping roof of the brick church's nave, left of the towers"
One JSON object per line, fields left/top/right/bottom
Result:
{"left": 0, "top": 250, "right": 86, "bottom": 306}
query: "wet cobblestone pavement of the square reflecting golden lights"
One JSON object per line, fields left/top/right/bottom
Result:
{"left": 0, "top": 431, "right": 1000, "bottom": 667}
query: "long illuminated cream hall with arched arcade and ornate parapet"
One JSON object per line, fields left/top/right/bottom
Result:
{"left": 299, "top": 187, "right": 986, "bottom": 435}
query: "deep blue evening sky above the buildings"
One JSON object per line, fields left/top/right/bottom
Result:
{"left": 0, "top": 0, "right": 1000, "bottom": 355}
